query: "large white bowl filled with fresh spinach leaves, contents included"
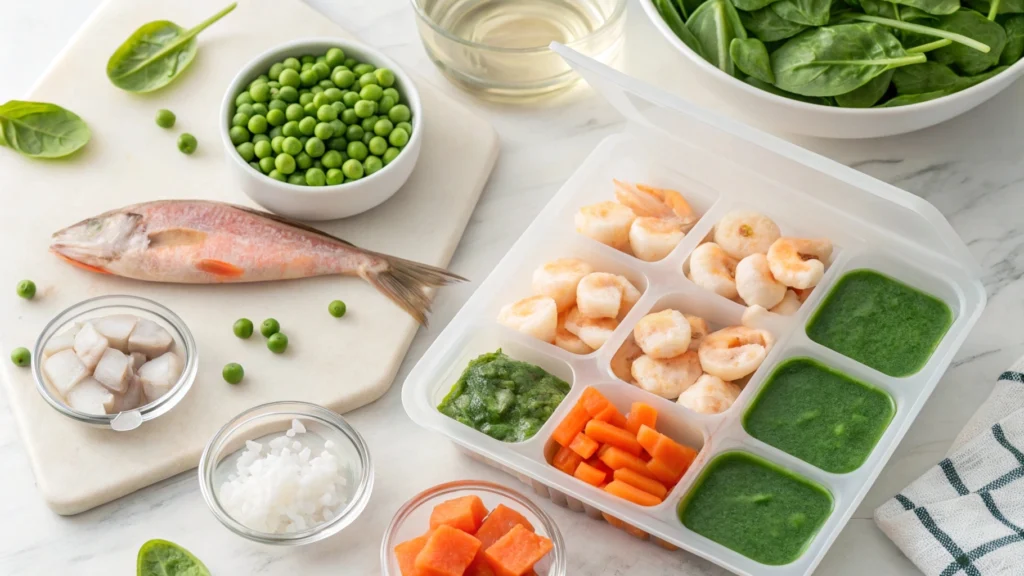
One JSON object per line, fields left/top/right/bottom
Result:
{"left": 642, "top": 0, "right": 1024, "bottom": 138}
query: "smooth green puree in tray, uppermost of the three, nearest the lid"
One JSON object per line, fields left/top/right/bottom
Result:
{"left": 807, "top": 270, "right": 953, "bottom": 377}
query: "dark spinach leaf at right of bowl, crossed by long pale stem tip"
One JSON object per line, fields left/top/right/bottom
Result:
{"left": 931, "top": 8, "right": 1007, "bottom": 76}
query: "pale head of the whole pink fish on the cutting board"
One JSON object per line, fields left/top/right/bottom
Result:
{"left": 50, "top": 211, "right": 145, "bottom": 272}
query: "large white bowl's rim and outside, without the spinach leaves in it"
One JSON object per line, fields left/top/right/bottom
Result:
{"left": 640, "top": 0, "right": 1024, "bottom": 138}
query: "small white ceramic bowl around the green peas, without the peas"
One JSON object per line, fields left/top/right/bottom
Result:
{"left": 220, "top": 38, "right": 424, "bottom": 220}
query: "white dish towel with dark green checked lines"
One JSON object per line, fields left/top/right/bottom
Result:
{"left": 874, "top": 359, "right": 1024, "bottom": 576}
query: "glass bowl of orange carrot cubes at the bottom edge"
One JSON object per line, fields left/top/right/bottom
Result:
{"left": 381, "top": 480, "right": 566, "bottom": 576}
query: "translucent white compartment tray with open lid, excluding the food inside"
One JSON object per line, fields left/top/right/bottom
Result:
{"left": 402, "top": 45, "right": 985, "bottom": 576}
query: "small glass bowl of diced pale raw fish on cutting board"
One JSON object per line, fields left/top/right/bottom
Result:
{"left": 32, "top": 295, "right": 199, "bottom": 431}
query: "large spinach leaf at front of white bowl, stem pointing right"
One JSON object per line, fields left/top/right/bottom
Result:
{"left": 771, "top": 24, "right": 927, "bottom": 96}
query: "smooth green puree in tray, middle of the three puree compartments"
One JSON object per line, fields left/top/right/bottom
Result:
{"left": 743, "top": 358, "right": 896, "bottom": 474}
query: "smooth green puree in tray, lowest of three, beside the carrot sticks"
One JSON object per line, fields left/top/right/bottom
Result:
{"left": 679, "top": 451, "right": 833, "bottom": 566}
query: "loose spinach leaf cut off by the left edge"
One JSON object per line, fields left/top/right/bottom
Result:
{"left": 0, "top": 100, "right": 91, "bottom": 158}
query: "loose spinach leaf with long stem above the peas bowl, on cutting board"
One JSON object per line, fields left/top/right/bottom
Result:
{"left": 106, "top": 4, "right": 238, "bottom": 92}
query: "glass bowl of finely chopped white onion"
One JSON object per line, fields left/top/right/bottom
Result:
{"left": 199, "top": 402, "right": 374, "bottom": 546}
